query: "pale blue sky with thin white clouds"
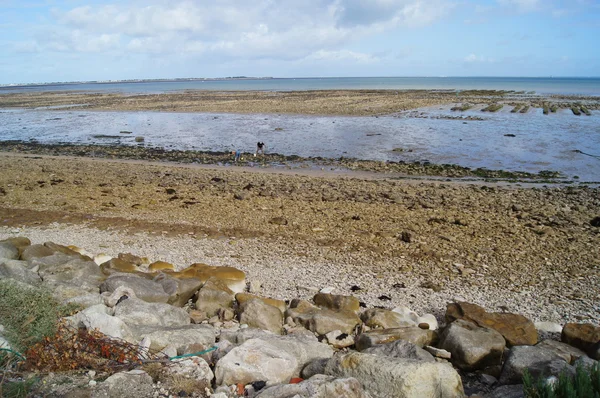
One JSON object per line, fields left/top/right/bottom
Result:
{"left": 0, "top": 0, "right": 600, "bottom": 84}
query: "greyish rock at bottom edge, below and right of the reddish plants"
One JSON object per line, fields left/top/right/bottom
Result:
{"left": 92, "top": 369, "right": 154, "bottom": 398}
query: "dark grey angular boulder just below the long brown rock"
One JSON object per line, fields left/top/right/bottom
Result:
{"left": 439, "top": 319, "right": 506, "bottom": 371}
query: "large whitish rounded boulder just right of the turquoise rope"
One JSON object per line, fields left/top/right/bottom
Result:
{"left": 215, "top": 339, "right": 298, "bottom": 385}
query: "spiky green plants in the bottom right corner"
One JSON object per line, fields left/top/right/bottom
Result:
{"left": 523, "top": 363, "right": 600, "bottom": 398}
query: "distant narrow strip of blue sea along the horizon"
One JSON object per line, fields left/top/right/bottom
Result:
{"left": 0, "top": 77, "right": 600, "bottom": 96}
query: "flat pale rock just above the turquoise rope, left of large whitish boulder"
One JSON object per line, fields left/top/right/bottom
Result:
{"left": 131, "top": 324, "right": 216, "bottom": 355}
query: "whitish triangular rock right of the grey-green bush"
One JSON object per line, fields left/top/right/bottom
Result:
{"left": 67, "top": 304, "right": 136, "bottom": 342}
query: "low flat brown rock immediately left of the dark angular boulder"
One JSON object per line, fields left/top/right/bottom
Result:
{"left": 355, "top": 327, "right": 438, "bottom": 351}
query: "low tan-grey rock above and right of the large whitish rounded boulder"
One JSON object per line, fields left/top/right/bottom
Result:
{"left": 286, "top": 300, "right": 361, "bottom": 336}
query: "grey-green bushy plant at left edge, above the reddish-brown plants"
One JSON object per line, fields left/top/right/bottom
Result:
{"left": 0, "top": 279, "right": 79, "bottom": 352}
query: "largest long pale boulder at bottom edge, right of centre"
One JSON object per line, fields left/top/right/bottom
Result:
{"left": 325, "top": 352, "right": 464, "bottom": 398}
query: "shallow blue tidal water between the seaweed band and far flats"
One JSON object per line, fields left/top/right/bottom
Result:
{"left": 0, "top": 106, "right": 600, "bottom": 181}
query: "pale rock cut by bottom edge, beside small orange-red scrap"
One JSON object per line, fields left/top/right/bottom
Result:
{"left": 256, "top": 375, "right": 370, "bottom": 398}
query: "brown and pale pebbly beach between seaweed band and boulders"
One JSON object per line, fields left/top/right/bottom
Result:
{"left": 0, "top": 154, "right": 600, "bottom": 323}
